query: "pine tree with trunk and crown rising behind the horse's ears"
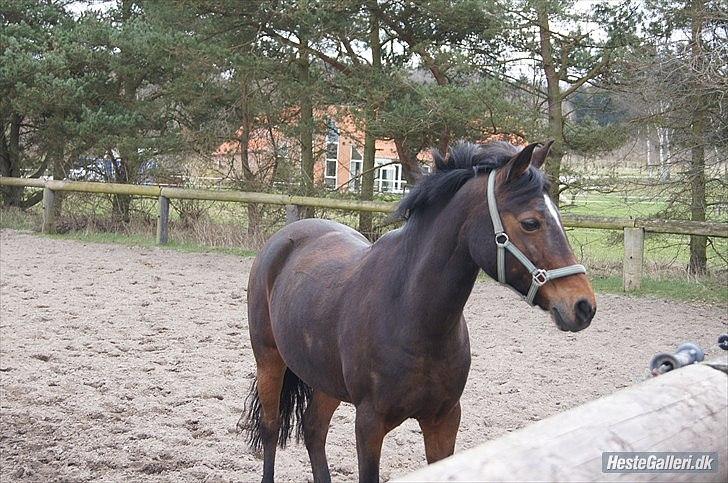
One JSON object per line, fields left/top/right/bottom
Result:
{"left": 494, "top": 0, "right": 638, "bottom": 203}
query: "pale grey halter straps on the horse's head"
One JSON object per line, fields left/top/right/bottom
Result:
{"left": 486, "top": 169, "right": 586, "bottom": 306}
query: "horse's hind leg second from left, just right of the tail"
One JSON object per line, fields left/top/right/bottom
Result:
{"left": 303, "top": 390, "right": 341, "bottom": 483}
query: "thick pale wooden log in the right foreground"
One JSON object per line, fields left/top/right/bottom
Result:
{"left": 396, "top": 358, "right": 728, "bottom": 482}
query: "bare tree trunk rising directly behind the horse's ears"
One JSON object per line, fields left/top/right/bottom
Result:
{"left": 538, "top": 6, "right": 564, "bottom": 206}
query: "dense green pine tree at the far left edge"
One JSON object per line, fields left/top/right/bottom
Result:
{"left": 0, "top": 1, "right": 83, "bottom": 208}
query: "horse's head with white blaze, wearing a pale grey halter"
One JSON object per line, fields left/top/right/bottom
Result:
{"left": 467, "top": 139, "right": 596, "bottom": 332}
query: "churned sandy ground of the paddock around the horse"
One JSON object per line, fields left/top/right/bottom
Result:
{"left": 0, "top": 230, "right": 728, "bottom": 481}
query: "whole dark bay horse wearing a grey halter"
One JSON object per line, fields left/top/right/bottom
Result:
{"left": 239, "top": 141, "right": 596, "bottom": 482}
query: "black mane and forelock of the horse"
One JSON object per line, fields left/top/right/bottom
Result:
{"left": 394, "top": 141, "right": 547, "bottom": 219}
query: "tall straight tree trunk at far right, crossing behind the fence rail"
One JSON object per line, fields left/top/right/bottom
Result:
{"left": 689, "top": 0, "right": 707, "bottom": 275}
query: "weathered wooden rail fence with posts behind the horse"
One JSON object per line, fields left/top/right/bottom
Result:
{"left": 0, "top": 176, "right": 728, "bottom": 292}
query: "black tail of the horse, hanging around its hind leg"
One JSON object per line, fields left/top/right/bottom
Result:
{"left": 237, "top": 369, "right": 312, "bottom": 452}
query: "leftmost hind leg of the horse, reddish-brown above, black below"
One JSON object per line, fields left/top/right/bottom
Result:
{"left": 256, "top": 348, "right": 286, "bottom": 483}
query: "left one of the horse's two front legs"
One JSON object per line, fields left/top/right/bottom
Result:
{"left": 356, "top": 404, "right": 388, "bottom": 483}
